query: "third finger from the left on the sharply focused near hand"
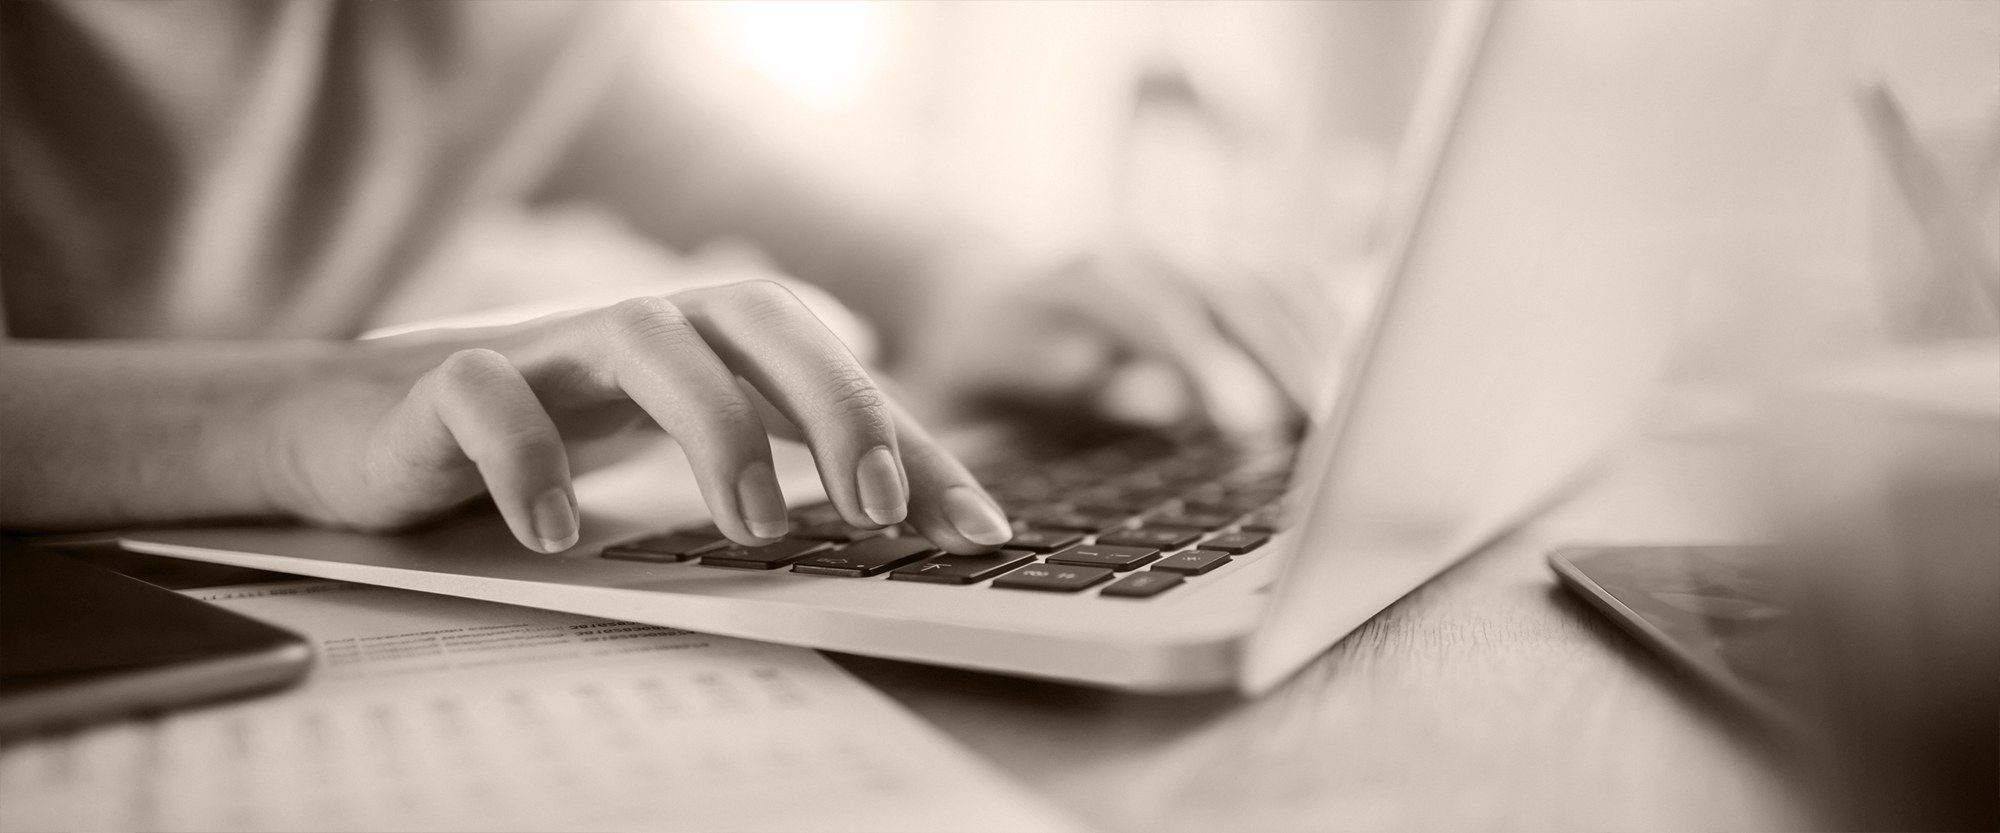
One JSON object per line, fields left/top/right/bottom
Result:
{"left": 674, "top": 280, "right": 910, "bottom": 527}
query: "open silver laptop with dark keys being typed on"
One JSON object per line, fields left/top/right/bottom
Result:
{"left": 122, "top": 2, "right": 1670, "bottom": 695}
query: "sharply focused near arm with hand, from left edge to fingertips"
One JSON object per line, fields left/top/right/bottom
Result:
{"left": 0, "top": 282, "right": 1012, "bottom": 553}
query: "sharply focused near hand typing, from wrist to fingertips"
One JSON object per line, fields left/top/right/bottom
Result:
{"left": 270, "top": 280, "right": 1010, "bottom": 553}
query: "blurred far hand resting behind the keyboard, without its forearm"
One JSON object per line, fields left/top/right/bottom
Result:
{"left": 900, "top": 247, "right": 1336, "bottom": 445}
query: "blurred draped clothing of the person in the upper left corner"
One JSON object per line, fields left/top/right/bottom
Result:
{"left": 0, "top": 0, "right": 638, "bottom": 338}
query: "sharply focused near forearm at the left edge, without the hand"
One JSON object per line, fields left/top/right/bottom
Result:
{"left": 0, "top": 340, "right": 348, "bottom": 531}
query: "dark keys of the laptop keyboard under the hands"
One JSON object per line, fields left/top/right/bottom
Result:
{"left": 604, "top": 437, "right": 1292, "bottom": 599}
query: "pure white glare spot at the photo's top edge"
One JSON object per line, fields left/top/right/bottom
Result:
{"left": 710, "top": 0, "right": 884, "bottom": 108}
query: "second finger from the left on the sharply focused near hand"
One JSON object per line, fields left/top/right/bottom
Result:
{"left": 586, "top": 298, "right": 788, "bottom": 545}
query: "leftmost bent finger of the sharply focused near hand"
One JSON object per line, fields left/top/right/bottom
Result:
{"left": 388, "top": 350, "right": 578, "bottom": 553}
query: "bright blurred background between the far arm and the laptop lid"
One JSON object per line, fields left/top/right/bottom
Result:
{"left": 656, "top": 0, "right": 1436, "bottom": 276}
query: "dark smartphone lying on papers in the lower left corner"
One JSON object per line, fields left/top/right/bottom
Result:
{"left": 0, "top": 539, "right": 312, "bottom": 735}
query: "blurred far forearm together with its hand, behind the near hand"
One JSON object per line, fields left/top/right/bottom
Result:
{"left": 542, "top": 22, "right": 1290, "bottom": 439}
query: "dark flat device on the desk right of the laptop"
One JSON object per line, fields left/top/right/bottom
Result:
{"left": 1548, "top": 547, "right": 1804, "bottom": 729}
